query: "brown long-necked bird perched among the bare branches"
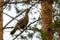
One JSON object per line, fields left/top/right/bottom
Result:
{"left": 10, "top": 9, "right": 29, "bottom": 35}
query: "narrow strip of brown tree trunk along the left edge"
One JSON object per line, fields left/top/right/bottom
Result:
{"left": 0, "top": 0, "right": 3, "bottom": 40}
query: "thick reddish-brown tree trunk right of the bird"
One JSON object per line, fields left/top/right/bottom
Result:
{"left": 41, "top": 0, "right": 53, "bottom": 40}
